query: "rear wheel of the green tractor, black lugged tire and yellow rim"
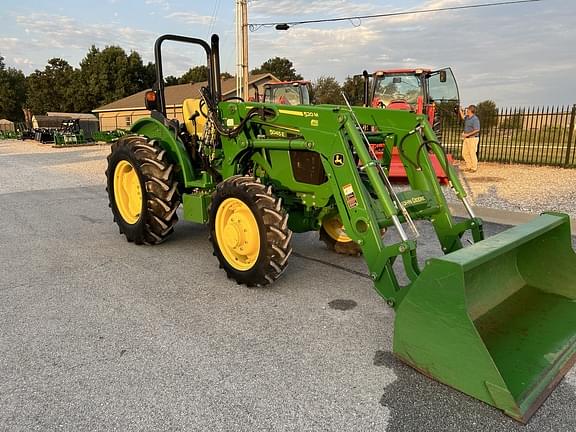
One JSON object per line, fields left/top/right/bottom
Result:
{"left": 106, "top": 135, "right": 180, "bottom": 245}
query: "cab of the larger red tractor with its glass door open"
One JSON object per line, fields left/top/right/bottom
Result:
{"left": 364, "top": 68, "right": 460, "bottom": 124}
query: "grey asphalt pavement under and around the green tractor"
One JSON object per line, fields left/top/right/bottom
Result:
{"left": 0, "top": 142, "right": 576, "bottom": 432}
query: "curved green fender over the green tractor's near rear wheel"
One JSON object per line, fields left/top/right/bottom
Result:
{"left": 130, "top": 117, "right": 194, "bottom": 188}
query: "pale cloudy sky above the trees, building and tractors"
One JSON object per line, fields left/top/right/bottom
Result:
{"left": 0, "top": 0, "right": 576, "bottom": 107}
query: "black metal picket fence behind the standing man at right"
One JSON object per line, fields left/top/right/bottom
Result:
{"left": 440, "top": 105, "right": 576, "bottom": 168}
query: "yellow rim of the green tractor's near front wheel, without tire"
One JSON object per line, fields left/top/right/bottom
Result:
{"left": 215, "top": 198, "right": 260, "bottom": 271}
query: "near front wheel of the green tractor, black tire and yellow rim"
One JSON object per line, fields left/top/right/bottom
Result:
{"left": 210, "top": 176, "right": 292, "bottom": 287}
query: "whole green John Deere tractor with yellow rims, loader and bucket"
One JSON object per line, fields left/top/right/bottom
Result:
{"left": 107, "top": 35, "right": 576, "bottom": 421}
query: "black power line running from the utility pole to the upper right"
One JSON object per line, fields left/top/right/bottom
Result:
{"left": 248, "top": 0, "right": 542, "bottom": 32}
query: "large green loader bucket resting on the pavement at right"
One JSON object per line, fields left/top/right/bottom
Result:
{"left": 394, "top": 213, "right": 576, "bottom": 422}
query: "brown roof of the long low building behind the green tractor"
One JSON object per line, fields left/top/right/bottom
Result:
{"left": 92, "top": 73, "right": 278, "bottom": 112}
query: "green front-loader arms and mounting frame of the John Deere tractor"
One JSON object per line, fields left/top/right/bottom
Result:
{"left": 220, "top": 103, "right": 482, "bottom": 307}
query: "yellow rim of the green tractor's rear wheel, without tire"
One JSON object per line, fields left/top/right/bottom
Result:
{"left": 114, "top": 160, "right": 142, "bottom": 225}
